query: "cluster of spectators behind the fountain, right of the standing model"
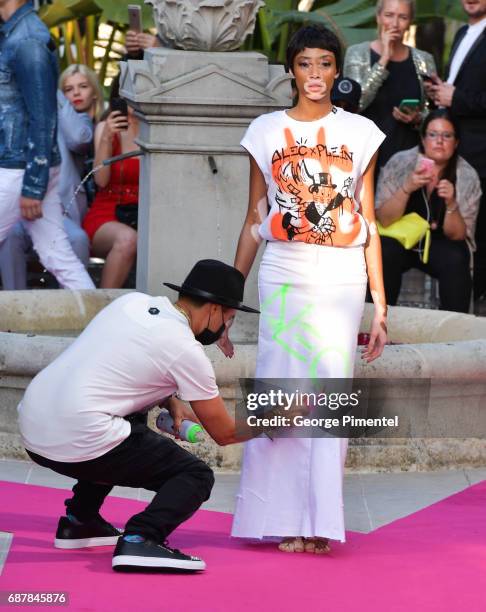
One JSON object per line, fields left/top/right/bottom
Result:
{"left": 343, "top": 0, "right": 486, "bottom": 312}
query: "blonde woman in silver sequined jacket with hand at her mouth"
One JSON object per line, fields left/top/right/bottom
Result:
{"left": 343, "top": 0, "right": 437, "bottom": 169}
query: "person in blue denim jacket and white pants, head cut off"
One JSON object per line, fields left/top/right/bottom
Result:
{"left": 0, "top": 0, "right": 94, "bottom": 289}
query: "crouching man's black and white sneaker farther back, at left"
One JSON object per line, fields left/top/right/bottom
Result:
{"left": 54, "top": 515, "right": 123, "bottom": 549}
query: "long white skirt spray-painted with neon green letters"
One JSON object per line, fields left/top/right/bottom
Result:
{"left": 232, "top": 242, "right": 367, "bottom": 542}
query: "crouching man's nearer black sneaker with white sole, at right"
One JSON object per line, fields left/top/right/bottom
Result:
{"left": 112, "top": 536, "right": 206, "bottom": 571}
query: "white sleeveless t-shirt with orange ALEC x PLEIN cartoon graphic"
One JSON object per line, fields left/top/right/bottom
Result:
{"left": 241, "top": 107, "right": 385, "bottom": 247}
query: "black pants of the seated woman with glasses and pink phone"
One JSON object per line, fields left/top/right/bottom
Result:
{"left": 381, "top": 236, "right": 472, "bottom": 312}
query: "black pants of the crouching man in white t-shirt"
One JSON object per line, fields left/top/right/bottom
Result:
{"left": 27, "top": 423, "right": 214, "bottom": 542}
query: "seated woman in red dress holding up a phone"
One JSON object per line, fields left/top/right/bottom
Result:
{"left": 83, "top": 77, "right": 139, "bottom": 288}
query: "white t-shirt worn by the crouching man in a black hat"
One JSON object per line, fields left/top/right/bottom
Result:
{"left": 18, "top": 293, "right": 219, "bottom": 463}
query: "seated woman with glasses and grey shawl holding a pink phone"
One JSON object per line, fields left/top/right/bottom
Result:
{"left": 376, "top": 109, "right": 481, "bottom": 312}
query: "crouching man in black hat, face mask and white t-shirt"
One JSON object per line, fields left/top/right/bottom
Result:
{"left": 19, "top": 260, "right": 258, "bottom": 570}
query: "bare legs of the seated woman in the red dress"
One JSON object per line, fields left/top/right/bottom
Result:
{"left": 92, "top": 221, "right": 137, "bottom": 289}
